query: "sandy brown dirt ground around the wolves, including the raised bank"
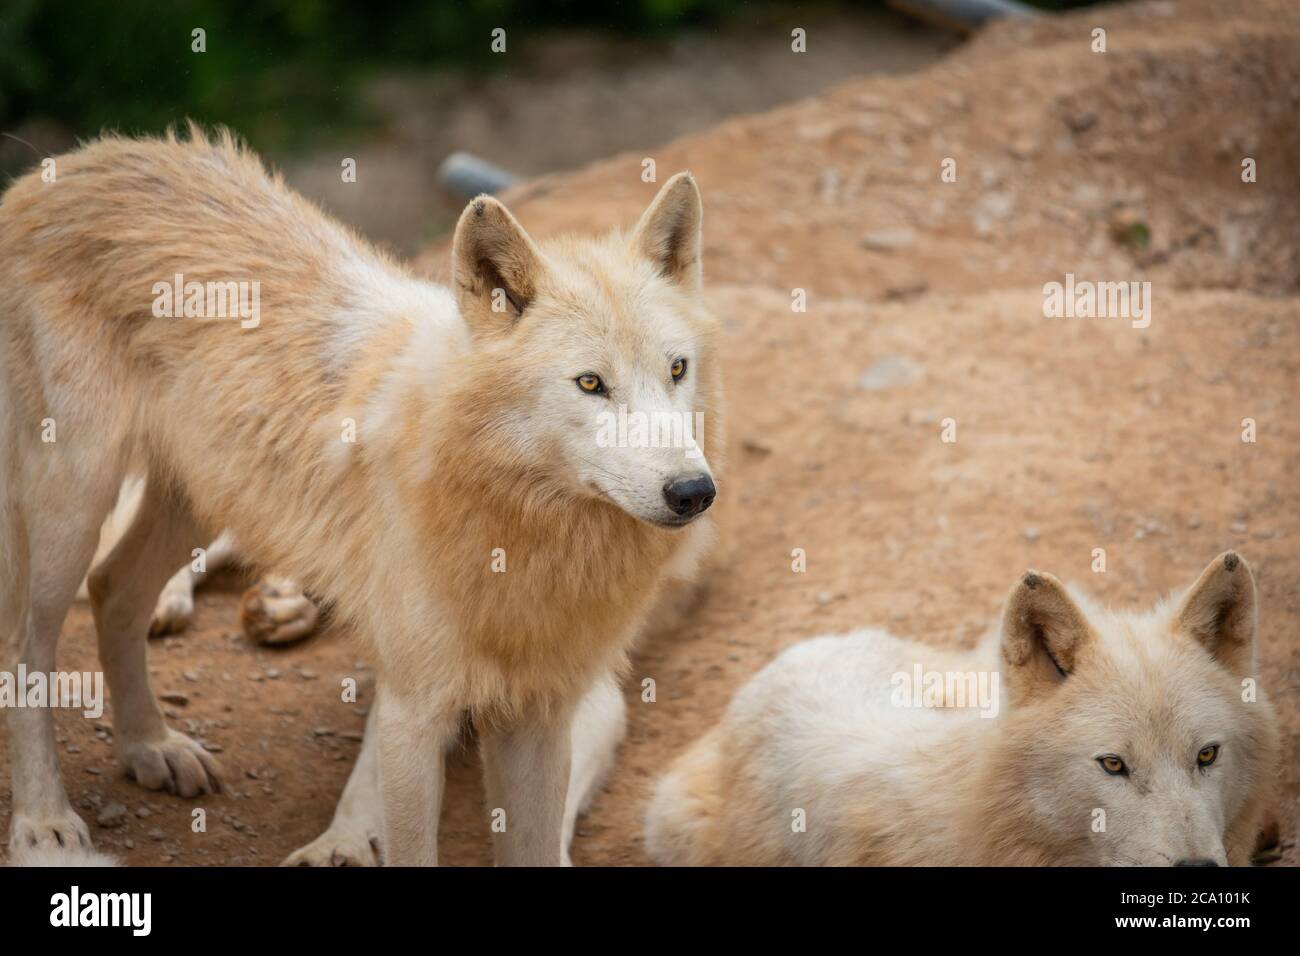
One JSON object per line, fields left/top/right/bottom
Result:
{"left": 0, "top": 0, "right": 1300, "bottom": 865}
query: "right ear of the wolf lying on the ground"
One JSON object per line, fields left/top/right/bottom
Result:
{"left": 1174, "top": 551, "right": 1258, "bottom": 674}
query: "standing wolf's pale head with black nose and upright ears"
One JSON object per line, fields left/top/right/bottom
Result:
{"left": 452, "top": 173, "right": 719, "bottom": 527}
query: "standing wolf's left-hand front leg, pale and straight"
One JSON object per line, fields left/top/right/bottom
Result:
{"left": 376, "top": 688, "right": 460, "bottom": 866}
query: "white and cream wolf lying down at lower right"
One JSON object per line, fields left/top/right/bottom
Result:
{"left": 646, "top": 551, "right": 1279, "bottom": 866}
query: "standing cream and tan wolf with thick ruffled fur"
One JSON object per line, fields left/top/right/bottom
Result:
{"left": 0, "top": 129, "right": 720, "bottom": 864}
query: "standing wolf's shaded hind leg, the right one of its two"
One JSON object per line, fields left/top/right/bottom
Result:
{"left": 88, "top": 479, "right": 221, "bottom": 796}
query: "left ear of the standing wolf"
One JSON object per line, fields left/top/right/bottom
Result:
{"left": 451, "top": 196, "right": 543, "bottom": 334}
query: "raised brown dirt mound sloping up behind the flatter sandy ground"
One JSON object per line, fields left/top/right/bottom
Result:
{"left": 426, "top": 0, "right": 1300, "bottom": 298}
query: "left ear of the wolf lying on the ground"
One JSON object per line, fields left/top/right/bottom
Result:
{"left": 1002, "top": 571, "right": 1095, "bottom": 700}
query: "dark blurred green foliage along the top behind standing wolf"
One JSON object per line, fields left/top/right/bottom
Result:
{"left": 0, "top": 0, "right": 737, "bottom": 140}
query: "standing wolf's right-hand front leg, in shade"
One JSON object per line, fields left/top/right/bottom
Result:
{"left": 480, "top": 710, "right": 573, "bottom": 866}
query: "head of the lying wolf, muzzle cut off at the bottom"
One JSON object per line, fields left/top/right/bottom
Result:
{"left": 997, "top": 551, "right": 1278, "bottom": 865}
